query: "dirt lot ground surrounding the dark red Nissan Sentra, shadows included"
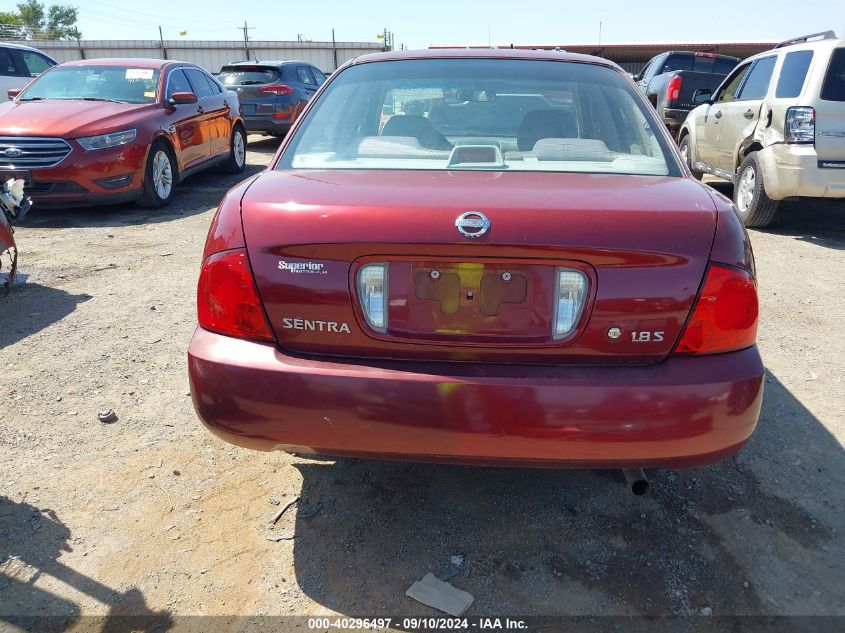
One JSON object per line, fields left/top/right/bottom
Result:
{"left": 0, "top": 137, "right": 845, "bottom": 630}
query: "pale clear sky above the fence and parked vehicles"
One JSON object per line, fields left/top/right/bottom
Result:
{"left": 59, "top": 0, "right": 845, "bottom": 49}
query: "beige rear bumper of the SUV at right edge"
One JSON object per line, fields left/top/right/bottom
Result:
{"left": 758, "top": 143, "right": 845, "bottom": 200}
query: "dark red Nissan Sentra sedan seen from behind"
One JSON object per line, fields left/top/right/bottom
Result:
{"left": 188, "top": 50, "right": 763, "bottom": 468}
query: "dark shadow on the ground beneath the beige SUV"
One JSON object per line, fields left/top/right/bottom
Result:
{"left": 707, "top": 181, "right": 845, "bottom": 250}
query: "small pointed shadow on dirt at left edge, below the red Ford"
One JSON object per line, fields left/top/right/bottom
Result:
{"left": 0, "top": 282, "right": 91, "bottom": 349}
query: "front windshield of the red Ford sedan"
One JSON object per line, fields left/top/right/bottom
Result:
{"left": 19, "top": 65, "right": 160, "bottom": 103}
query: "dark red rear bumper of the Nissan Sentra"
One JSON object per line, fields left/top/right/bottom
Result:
{"left": 188, "top": 328, "right": 763, "bottom": 468}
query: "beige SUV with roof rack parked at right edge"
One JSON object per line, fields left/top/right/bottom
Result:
{"left": 679, "top": 31, "right": 845, "bottom": 227}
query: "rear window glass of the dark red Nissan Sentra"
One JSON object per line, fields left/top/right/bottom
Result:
{"left": 279, "top": 59, "right": 680, "bottom": 176}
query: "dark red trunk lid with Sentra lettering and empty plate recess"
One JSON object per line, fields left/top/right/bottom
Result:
{"left": 243, "top": 170, "right": 716, "bottom": 363}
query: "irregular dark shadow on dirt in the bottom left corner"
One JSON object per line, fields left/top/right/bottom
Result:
{"left": 0, "top": 495, "right": 173, "bottom": 632}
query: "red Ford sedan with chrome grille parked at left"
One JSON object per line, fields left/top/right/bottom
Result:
{"left": 0, "top": 59, "right": 246, "bottom": 207}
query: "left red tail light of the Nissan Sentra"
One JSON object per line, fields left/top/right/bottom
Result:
{"left": 197, "top": 248, "right": 273, "bottom": 341}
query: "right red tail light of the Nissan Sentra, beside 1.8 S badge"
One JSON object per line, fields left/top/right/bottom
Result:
{"left": 675, "top": 264, "right": 758, "bottom": 354}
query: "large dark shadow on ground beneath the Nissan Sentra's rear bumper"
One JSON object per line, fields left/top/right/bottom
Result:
{"left": 292, "top": 374, "right": 845, "bottom": 626}
